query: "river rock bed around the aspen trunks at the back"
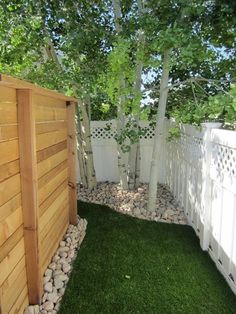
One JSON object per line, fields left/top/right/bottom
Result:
{"left": 78, "top": 182, "right": 187, "bottom": 224}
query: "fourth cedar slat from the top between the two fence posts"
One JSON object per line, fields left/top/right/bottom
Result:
{"left": 36, "top": 129, "right": 67, "bottom": 151}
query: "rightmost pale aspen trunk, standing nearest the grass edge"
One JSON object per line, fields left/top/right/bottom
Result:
{"left": 148, "top": 49, "right": 172, "bottom": 211}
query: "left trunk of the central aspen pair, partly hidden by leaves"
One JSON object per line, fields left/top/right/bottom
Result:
{"left": 112, "top": 0, "right": 128, "bottom": 190}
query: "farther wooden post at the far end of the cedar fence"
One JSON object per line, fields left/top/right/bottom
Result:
{"left": 67, "top": 101, "right": 78, "bottom": 225}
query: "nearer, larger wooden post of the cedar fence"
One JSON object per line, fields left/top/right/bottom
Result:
{"left": 17, "top": 89, "right": 42, "bottom": 304}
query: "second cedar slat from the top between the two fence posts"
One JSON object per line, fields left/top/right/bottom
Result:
{"left": 35, "top": 106, "right": 66, "bottom": 122}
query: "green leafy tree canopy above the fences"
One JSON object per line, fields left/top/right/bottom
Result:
{"left": 0, "top": 0, "right": 236, "bottom": 119}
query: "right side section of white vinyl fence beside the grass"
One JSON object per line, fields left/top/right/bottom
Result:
{"left": 164, "top": 124, "right": 236, "bottom": 293}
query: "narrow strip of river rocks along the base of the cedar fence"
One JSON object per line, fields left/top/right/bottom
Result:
{"left": 24, "top": 218, "right": 87, "bottom": 314}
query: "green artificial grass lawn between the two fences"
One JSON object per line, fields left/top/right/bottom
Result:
{"left": 59, "top": 202, "right": 236, "bottom": 314}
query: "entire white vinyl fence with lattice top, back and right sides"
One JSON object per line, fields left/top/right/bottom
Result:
{"left": 80, "top": 121, "right": 236, "bottom": 293}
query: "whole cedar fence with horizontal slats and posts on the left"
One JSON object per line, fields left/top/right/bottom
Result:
{"left": 0, "top": 75, "right": 77, "bottom": 314}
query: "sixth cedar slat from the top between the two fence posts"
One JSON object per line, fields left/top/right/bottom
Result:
{"left": 37, "top": 149, "right": 67, "bottom": 178}
